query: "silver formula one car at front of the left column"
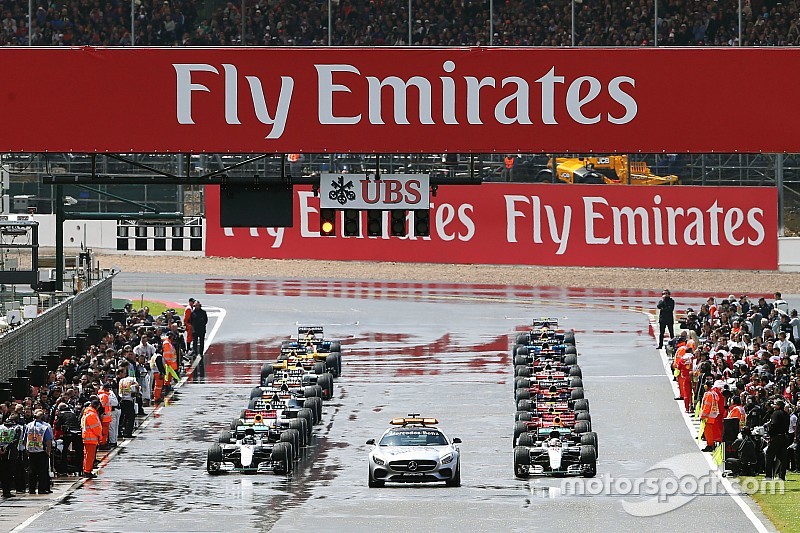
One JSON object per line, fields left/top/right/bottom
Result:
{"left": 206, "top": 427, "right": 295, "bottom": 475}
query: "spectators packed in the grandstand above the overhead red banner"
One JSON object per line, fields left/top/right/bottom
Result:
{"left": 0, "top": 0, "right": 800, "bottom": 46}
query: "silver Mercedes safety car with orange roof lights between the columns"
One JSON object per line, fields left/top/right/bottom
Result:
{"left": 367, "top": 413, "right": 461, "bottom": 487}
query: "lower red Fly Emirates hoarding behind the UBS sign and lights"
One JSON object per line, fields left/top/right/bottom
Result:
{"left": 206, "top": 184, "right": 778, "bottom": 270}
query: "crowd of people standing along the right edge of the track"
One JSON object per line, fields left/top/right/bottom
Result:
{"left": 659, "top": 291, "right": 800, "bottom": 479}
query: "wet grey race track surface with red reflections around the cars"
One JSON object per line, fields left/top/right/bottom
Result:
{"left": 18, "top": 274, "right": 771, "bottom": 532}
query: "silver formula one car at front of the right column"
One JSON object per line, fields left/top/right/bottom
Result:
{"left": 514, "top": 428, "right": 597, "bottom": 478}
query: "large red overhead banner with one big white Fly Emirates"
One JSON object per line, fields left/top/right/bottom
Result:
{"left": 0, "top": 47, "right": 800, "bottom": 153}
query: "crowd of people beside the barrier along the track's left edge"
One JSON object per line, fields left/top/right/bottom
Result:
{"left": 0, "top": 299, "right": 207, "bottom": 498}
